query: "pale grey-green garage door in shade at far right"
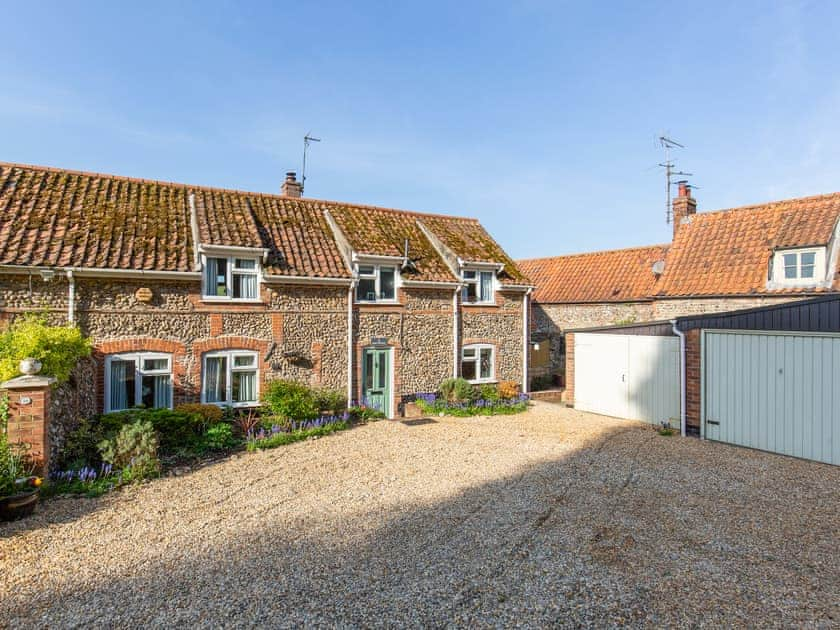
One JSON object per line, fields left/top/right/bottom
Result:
{"left": 703, "top": 331, "right": 840, "bottom": 464}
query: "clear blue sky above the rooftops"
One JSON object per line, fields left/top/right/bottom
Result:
{"left": 0, "top": 0, "right": 840, "bottom": 257}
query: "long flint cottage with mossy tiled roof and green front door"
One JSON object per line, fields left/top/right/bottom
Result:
{"left": 0, "top": 163, "right": 532, "bottom": 462}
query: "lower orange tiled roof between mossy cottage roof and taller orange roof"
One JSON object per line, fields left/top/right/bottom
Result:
{"left": 517, "top": 245, "right": 667, "bottom": 303}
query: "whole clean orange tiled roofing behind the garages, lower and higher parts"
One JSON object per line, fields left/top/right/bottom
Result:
{"left": 518, "top": 193, "right": 840, "bottom": 303}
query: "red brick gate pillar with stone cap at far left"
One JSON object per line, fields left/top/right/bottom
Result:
{"left": 0, "top": 376, "right": 55, "bottom": 474}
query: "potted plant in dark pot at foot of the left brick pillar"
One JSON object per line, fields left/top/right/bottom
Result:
{"left": 0, "top": 396, "right": 41, "bottom": 521}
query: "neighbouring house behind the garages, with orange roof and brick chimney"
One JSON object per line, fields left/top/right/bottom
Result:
{"left": 517, "top": 182, "right": 840, "bottom": 382}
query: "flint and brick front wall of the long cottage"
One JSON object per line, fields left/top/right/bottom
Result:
{"left": 0, "top": 272, "right": 522, "bottom": 434}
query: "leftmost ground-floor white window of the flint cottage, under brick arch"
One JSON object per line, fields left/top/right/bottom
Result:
{"left": 105, "top": 352, "right": 172, "bottom": 413}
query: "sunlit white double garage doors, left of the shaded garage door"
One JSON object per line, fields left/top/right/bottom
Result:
{"left": 574, "top": 333, "right": 680, "bottom": 424}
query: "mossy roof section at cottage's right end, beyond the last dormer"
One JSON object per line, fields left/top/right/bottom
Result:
{"left": 420, "top": 215, "right": 531, "bottom": 284}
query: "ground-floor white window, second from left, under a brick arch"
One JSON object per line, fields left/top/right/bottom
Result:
{"left": 201, "top": 350, "right": 260, "bottom": 407}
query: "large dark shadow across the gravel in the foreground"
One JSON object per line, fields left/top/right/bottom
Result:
{"left": 0, "top": 427, "right": 840, "bottom": 627}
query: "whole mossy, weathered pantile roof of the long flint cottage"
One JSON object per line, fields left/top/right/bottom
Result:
{"left": 0, "top": 162, "right": 524, "bottom": 281}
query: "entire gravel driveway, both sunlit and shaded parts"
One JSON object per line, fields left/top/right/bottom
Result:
{"left": 0, "top": 403, "right": 840, "bottom": 627}
